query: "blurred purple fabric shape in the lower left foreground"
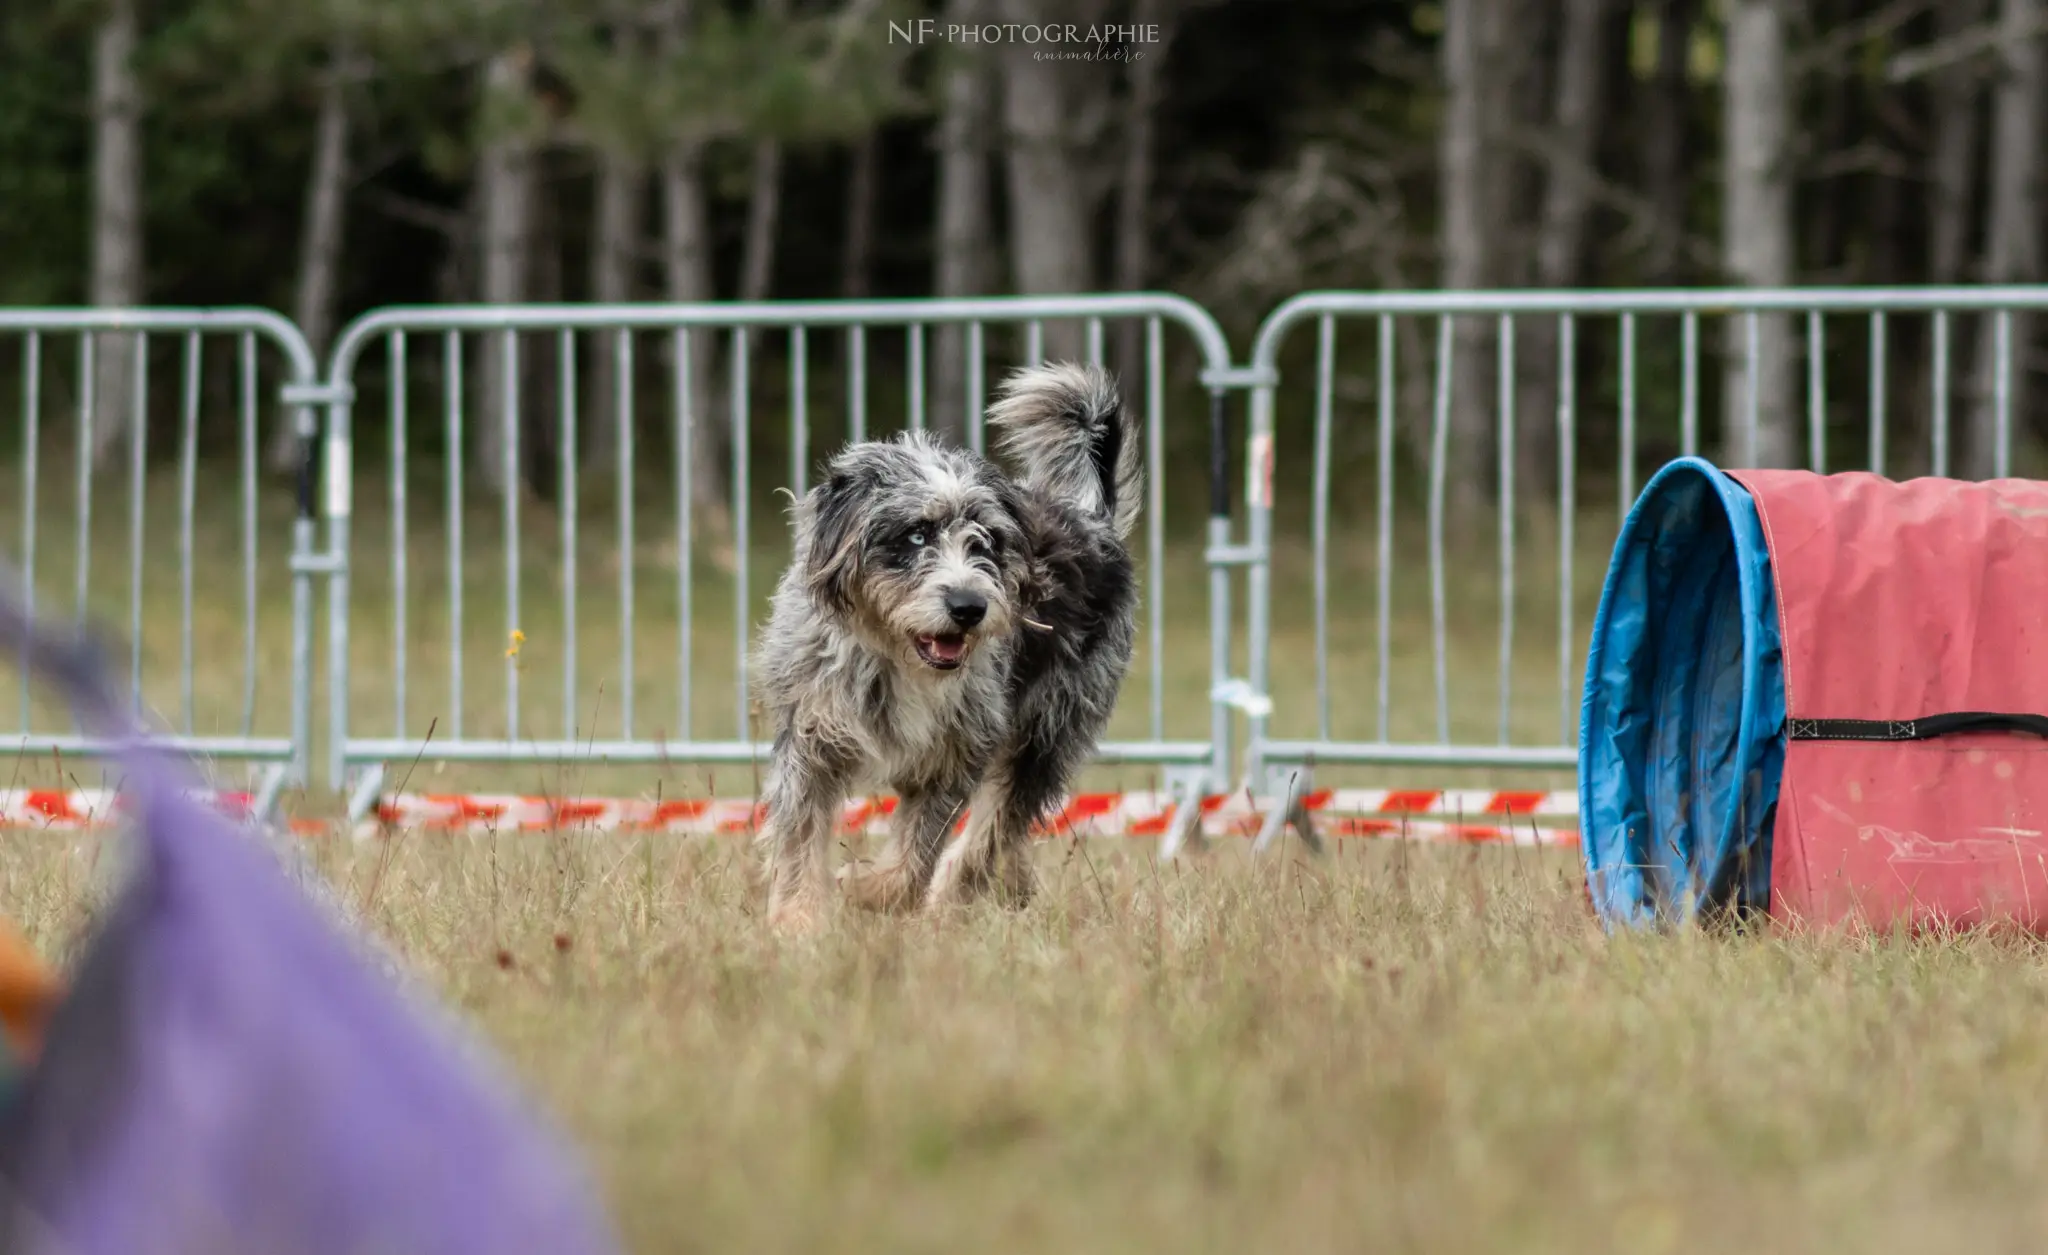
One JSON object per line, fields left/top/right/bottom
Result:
{"left": 0, "top": 596, "right": 618, "bottom": 1255}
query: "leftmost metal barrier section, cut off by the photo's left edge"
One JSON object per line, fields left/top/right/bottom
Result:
{"left": 0, "top": 309, "right": 319, "bottom": 813}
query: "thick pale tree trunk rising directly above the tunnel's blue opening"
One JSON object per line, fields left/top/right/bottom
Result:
{"left": 1722, "top": 0, "right": 1798, "bottom": 467}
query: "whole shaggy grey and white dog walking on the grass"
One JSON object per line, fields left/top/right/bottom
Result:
{"left": 760, "top": 364, "right": 1143, "bottom": 929}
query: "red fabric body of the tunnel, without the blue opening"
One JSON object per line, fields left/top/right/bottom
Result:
{"left": 1731, "top": 471, "right": 2048, "bottom": 932}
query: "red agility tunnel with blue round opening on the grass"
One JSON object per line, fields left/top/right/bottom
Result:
{"left": 1579, "top": 459, "right": 2048, "bottom": 932}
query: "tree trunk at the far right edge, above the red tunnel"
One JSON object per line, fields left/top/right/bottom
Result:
{"left": 1964, "top": 0, "right": 2044, "bottom": 479}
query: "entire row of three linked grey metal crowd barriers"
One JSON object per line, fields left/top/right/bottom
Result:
{"left": 0, "top": 287, "right": 2048, "bottom": 852}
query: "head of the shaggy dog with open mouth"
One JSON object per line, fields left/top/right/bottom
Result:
{"left": 799, "top": 436, "right": 1030, "bottom": 672}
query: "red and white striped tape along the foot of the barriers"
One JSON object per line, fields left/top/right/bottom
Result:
{"left": 0, "top": 788, "right": 1579, "bottom": 846}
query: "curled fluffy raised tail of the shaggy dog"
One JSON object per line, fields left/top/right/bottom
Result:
{"left": 989, "top": 362, "right": 1145, "bottom": 538}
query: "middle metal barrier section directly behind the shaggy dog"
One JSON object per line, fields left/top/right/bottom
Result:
{"left": 324, "top": 295, "right": 1237, "bottom": 831}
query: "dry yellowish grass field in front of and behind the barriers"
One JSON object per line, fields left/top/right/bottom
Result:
{"left": 0, "top": 464, "right": 2048, "bottom": 1255}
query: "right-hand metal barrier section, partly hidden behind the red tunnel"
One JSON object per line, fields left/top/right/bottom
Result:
{"left": 1245, "top": 287, "right": 2048, "bottom": 843}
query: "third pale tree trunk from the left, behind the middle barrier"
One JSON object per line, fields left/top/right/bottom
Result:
{"left": 475, "top": 49, "right": 535, "bottom": 493}
